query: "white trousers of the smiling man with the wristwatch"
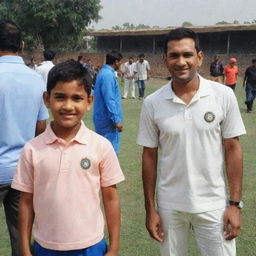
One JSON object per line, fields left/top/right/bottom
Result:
{"left": 158, "top": 209, "right": 236, "bottom": 256}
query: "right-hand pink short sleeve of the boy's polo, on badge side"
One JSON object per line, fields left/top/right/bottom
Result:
{"left": 100, "top": 141, "right": 124, "bottom": 187}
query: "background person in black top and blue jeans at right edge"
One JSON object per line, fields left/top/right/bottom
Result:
{"left": 243, "top": 59, "right": 256, "bottom": 113}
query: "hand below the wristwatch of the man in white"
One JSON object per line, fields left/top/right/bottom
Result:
{"left": 223, "top": 205, "right": 241, "bottom": 240}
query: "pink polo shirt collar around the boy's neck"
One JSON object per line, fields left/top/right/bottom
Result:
{"left": 44, "top": 121, "right": 89, "bottom": 144}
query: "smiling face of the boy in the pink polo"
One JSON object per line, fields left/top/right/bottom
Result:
{"left": 44, "top": 80, "right": 93, "bottom": 132}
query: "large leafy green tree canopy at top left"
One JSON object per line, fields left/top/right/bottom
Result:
{"left": 0, "top": 0, "right": 101, "bottom": 49}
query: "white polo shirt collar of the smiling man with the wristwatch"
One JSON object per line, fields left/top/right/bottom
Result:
{"left": 164, "top": 75, "right": 212, "bottom": 103}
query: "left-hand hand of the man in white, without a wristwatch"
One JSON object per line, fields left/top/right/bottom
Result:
{"left": 146, "top": 211, "right": 164, "bottom": 242}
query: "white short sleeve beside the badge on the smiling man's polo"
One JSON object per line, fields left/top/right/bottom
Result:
{"left": 221, "top": 89, "right": 246, "bottom": 139}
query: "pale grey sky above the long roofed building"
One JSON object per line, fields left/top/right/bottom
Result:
{"left": 90, "top": 0, "right": 256, "bottom": 30}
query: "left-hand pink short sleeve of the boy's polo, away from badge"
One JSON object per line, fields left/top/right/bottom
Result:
{"left": 11, "top": 144, "right": 34, "bottom": 193}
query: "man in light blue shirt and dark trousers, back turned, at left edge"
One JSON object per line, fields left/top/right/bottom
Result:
{"left": 0, "top": 19, "right": 48, "bottom": 256}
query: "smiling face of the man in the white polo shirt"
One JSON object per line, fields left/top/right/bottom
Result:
{"left": 164, "top": 38, "right": 203, "bottom": 84}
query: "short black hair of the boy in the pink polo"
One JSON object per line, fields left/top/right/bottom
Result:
{"left": 47, "top": 60, "right": 92, "bottom": 96}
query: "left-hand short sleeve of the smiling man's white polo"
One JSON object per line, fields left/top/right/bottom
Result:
{"left": 137, "top": 99, "right": 159, "bottom": 148}
